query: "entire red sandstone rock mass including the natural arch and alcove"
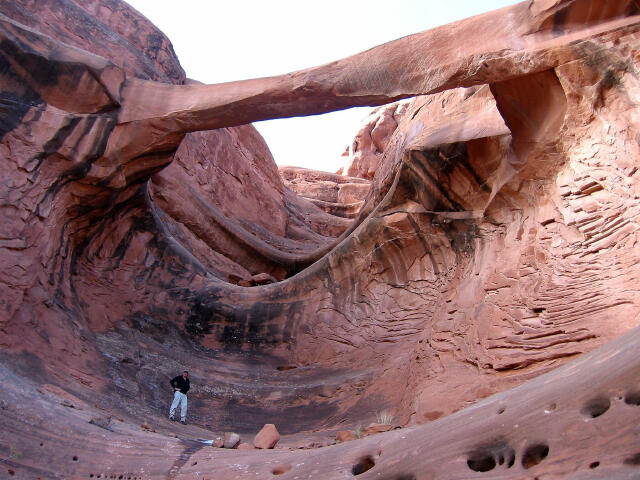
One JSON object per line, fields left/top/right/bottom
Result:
{"left": 0, "top": 0, "right": 640, "bottom": 479}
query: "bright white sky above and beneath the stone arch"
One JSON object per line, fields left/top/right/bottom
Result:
{"left": 127, "top": 0, "right": 518, "bottom": 172}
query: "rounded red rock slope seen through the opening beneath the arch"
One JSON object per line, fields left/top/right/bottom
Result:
{"left": 150, "top": 125, "right": 349, "bottom": 283}
